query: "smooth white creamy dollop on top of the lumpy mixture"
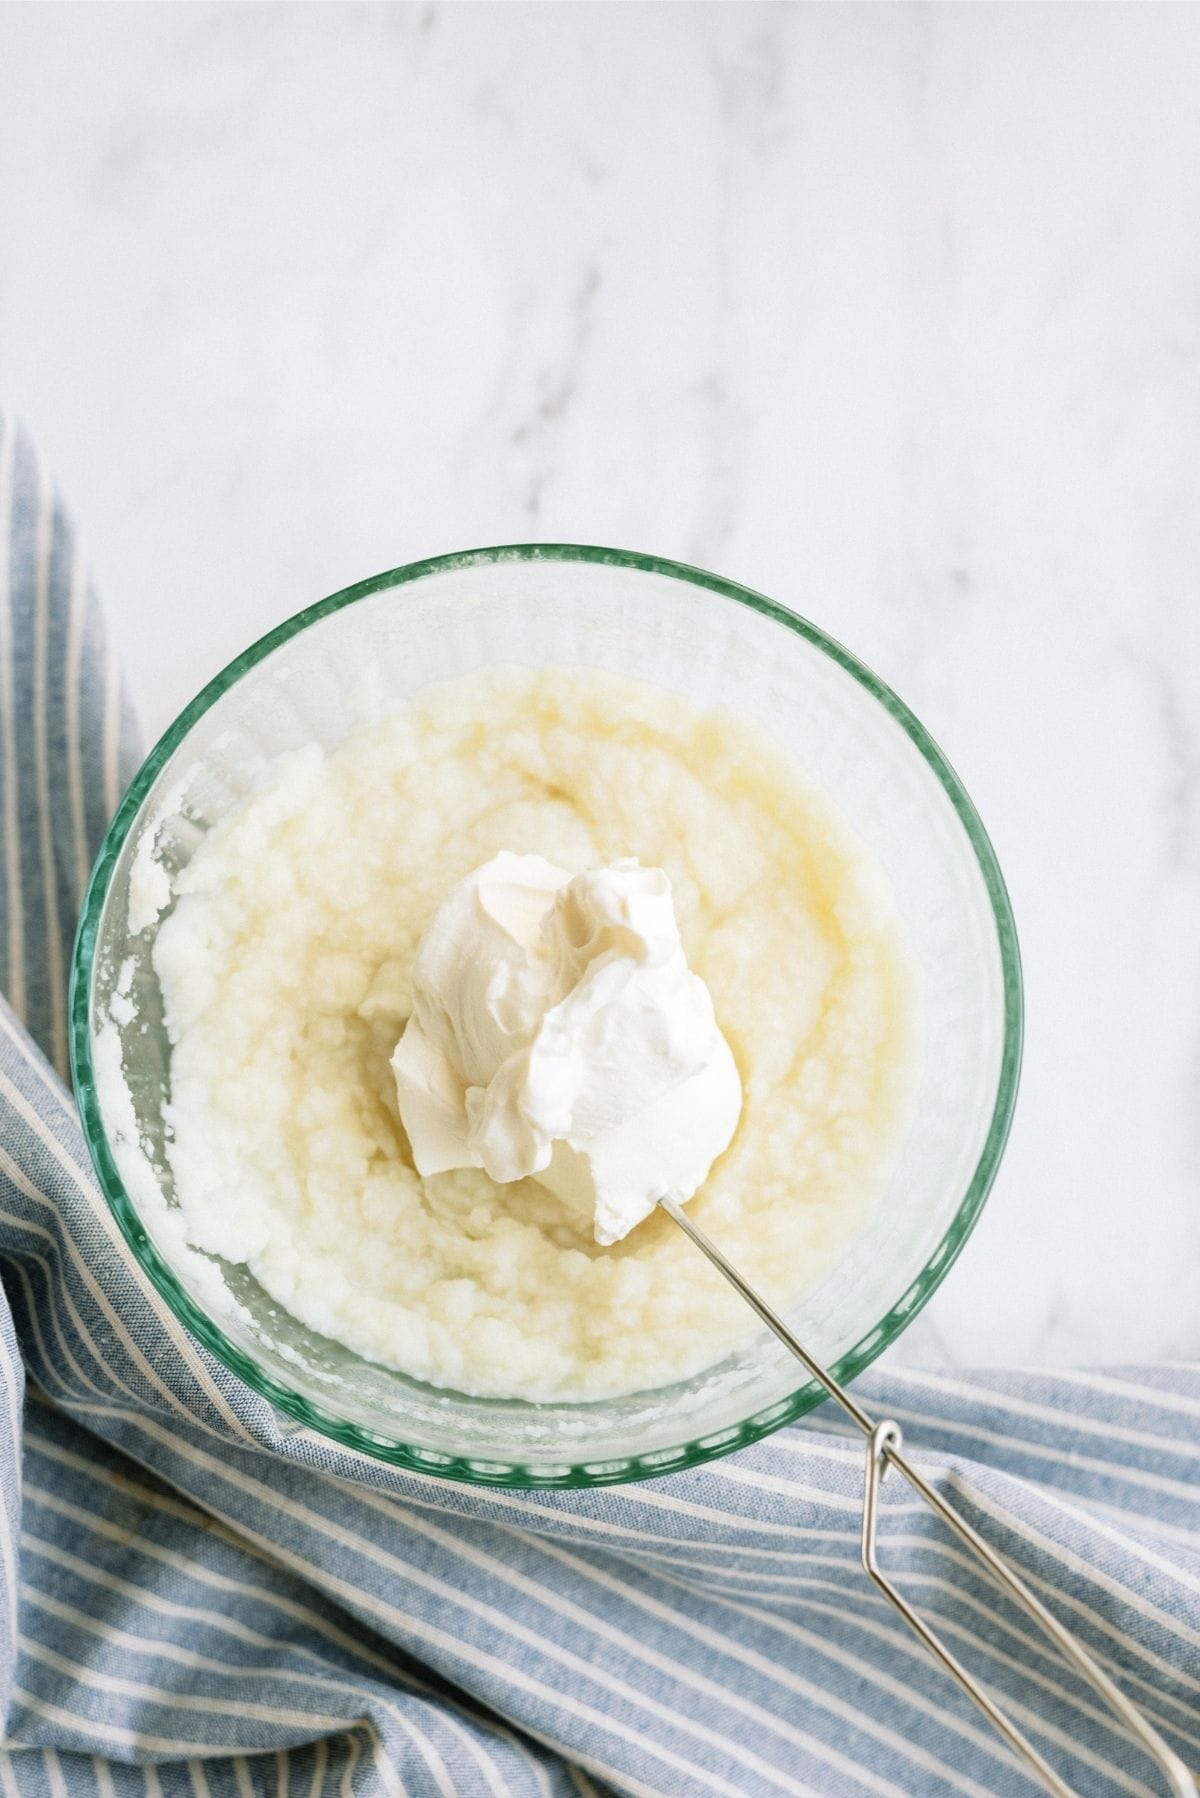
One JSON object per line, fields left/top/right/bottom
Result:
{"left": 392, "top": 852, "right": 741, "bottom": 1244}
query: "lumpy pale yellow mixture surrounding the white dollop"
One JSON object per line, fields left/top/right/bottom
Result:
{"left": 155, "top": 671, "right": 916, "bottom": 1399}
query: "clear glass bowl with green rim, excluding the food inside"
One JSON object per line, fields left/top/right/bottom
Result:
{"left": 72, "top": 543, "right": 1022, "bottom": 1487}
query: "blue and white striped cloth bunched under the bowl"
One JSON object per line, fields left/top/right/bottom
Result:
{"left": 0, "top": 408, "right": 1200, "bottom": 1798}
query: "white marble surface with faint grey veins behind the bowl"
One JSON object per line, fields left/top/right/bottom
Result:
{"left": 0, "top": 4, "right": 1200, "bottom": 1361}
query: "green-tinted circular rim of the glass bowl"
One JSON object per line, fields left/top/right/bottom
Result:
{"left": 70, "top": 543, "right": 1022, "bottom": 1489}
